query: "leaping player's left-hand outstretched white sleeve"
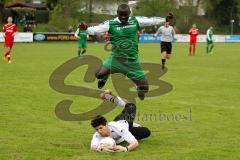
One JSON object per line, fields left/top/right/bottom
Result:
{"left": 87, "top": 21, "right": 109, "bottom": 35}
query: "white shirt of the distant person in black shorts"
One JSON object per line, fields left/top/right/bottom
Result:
{"left": 155, "top": 25, "right": 175, "bottom": 42}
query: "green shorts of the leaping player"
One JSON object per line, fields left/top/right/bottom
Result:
{"left": 103, "top": 55, "right": 147, "bottom": 80}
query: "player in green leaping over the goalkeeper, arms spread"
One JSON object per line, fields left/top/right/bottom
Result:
{"left": 87, "top": 4, "right": 165, "bottom": 100}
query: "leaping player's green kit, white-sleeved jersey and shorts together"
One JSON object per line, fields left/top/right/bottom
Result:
{"left": 87, "top": 16, "right": 165, "bottom": 79}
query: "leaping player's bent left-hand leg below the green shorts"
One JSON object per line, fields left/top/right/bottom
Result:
{"left": 95, "top": 66, "right": 110, "bottom": 89}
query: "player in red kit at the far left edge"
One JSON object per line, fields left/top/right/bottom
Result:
{"left": 2, "top": 17, "right": 17, "bottom": 64}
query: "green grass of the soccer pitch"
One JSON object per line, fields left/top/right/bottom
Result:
{"left": 0, "top": 42, "right": 240, "bottom": 160}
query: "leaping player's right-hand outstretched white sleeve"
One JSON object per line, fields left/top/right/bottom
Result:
{"left": 136, "top": 16, "right": 166, "bottom": 27}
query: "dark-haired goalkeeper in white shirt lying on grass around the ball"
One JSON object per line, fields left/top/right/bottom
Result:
{"left": 91, "top": 90, "right": 151, "bottom": 152}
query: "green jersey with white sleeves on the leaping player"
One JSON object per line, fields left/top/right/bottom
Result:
{"left": 87, "top": 16, "right": 165, "bottom": 58}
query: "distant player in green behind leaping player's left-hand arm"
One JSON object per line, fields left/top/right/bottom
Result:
{"left": 75, "top": 22, "right": 87, "bottom": 57}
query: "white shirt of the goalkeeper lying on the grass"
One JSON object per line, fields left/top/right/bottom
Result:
{"left": 91, "top": 120, "right": 137, "bottom": 148}
